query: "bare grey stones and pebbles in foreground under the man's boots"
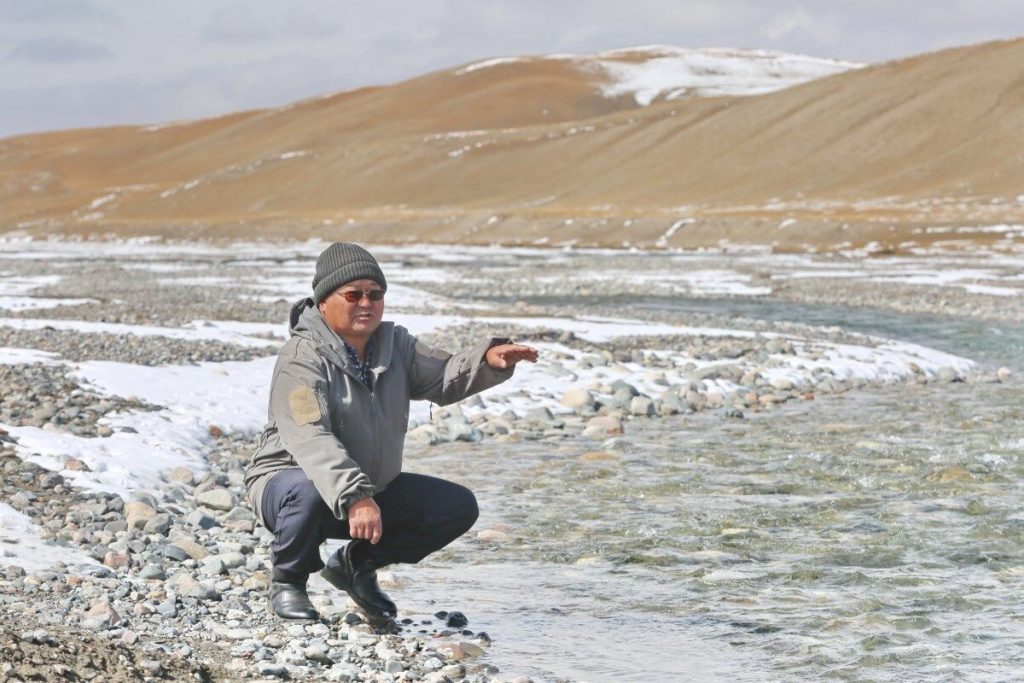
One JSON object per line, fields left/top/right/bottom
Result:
{"left": 0, "top": 435, "right": 507, "bottom": 681}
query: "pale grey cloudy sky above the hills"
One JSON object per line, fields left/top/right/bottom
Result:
{"left": 0, "top": 0, "right": 1024, "bottom": 137}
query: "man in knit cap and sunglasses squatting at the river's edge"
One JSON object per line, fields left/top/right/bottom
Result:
{"left": 246, "top": 243, "right": 537, "bottom": 620}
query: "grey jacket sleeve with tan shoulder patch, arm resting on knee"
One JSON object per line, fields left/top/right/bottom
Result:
{"left": 270, "top": 344, "right": 374, "bottom": 519}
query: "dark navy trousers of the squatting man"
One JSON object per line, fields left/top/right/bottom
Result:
{"left": 262, "top": 467, "right": 479, "bottom": 578}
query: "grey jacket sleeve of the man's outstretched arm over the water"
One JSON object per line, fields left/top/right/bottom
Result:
{"left": 402, "top": 333, "right": 515, "bottom": 405}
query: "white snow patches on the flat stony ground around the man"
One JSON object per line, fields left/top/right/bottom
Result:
{"left": 0, "top": 242, "right": 1024, "bottom": 566}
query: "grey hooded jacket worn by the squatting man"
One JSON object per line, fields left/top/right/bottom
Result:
{"left": 246, "top": 298, "right": 513, "bottom": 519}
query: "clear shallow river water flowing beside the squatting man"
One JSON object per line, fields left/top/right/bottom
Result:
{"left": 385, "top": 301, "right": 1024, "bottom": 681}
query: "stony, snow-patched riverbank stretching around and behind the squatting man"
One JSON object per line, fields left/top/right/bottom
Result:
{"left": 0, "top": 239, "right": 1024, "bottom": 682}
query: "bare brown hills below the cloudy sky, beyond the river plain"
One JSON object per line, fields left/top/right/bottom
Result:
{"left": 0, "top": 40, "right": 1024, "bottom": 248}
